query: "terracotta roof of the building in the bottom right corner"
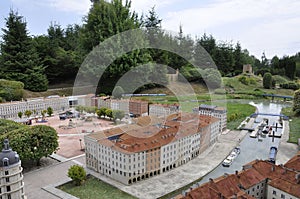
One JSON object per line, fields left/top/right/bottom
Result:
{"left": 175, "top": 157, "right": 300, "bottom": 199}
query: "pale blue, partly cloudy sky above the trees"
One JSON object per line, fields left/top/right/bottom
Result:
{"left": 0, "top": 0, "right": 300, "bottom": 59}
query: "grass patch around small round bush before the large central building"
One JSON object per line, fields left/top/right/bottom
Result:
{"left": 58, "top": 176, "right": 135, "bottom": 199}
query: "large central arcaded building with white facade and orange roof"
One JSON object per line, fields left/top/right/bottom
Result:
{"left": 84, "top": 113, "right": 220, "bottom": 185}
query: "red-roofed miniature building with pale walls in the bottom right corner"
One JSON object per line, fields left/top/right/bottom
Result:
{"left": 175, "top": 154, "right": 300, "bottom": 199}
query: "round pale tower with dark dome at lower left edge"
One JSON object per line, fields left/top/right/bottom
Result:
{"left": 0, "top": 139, "right": 26, "bottom": 199}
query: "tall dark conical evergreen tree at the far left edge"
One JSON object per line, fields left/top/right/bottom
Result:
{"left": 0, "top": 10, "right": 48, "bottom": 91}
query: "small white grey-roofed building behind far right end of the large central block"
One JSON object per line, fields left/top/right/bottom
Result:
{"left": 193, "top": 104, "right": 227, "bottom": 132}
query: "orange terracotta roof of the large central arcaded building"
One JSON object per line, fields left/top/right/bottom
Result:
{"left": 88, "top": 114, "right": 218, "bottom": 153}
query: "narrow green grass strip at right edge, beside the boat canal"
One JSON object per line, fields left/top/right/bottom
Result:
{"left": 281, "top": 107, "right": 300, "bottom": 144}
